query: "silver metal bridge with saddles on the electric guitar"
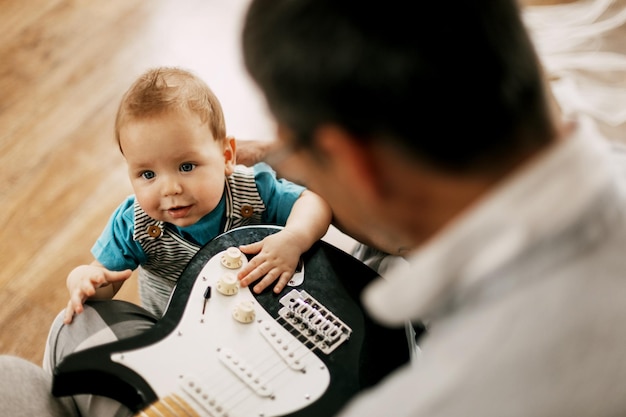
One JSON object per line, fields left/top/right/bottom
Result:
{"left": 278, "top": 290, "right": 352, "bottom": 354}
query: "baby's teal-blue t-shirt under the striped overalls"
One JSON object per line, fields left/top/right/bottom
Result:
{"left": 91, "top": 163, "right": 304, "bottom": 271}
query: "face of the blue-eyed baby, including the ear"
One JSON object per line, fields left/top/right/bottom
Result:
{"left": 120, "top": 112, "right": 235, "bottom": 227}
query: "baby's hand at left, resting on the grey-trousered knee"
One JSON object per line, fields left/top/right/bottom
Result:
{"left": 63, "top": 261, "right": 133, "bottom": 324}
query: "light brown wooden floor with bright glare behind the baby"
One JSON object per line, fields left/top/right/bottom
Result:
{"left": 0, "top": 0, "right": 280, "bottom": 363}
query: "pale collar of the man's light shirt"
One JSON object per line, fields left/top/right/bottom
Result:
{"left": 363, "top": 119, "right": 612, "bottom": 325}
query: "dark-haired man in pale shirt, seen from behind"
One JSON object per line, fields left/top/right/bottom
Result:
{"left": 243, "top": 0, "right": 626, "bottom": 417}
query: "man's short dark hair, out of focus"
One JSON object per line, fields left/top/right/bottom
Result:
{"left": 243, "top": 0, "right": 553, "bottom": 171}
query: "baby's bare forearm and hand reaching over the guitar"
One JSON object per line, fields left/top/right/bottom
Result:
{"left": 237, "top": 190, "right": 332, "bottom": 294}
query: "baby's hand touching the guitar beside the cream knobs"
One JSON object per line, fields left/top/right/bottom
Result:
{"left": 237, "top": 230, "right": 302, "bottom": 294}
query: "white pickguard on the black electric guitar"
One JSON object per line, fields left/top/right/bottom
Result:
{"left": 111, "top": 251, "right": 330, "bottom": 417}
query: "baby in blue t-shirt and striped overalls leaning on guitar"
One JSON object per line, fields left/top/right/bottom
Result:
{"left": 64, "top": 67, "right": 332, "bottom": 324}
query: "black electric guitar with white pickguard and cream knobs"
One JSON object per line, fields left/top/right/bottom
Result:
{"left": 52, "top": 226, "right": 409, "bottom": 417}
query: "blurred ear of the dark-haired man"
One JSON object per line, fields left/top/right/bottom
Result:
{"left": 314, "top": 125, "right": 384, "bottom": 201}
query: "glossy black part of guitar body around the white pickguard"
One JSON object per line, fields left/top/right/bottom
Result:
{"left": 53, "top": 226, "right": 409, "bottom": 417}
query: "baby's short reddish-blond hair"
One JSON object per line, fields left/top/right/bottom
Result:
{"left": 115, "top": 67, "right": 226, "bottom": 150}
